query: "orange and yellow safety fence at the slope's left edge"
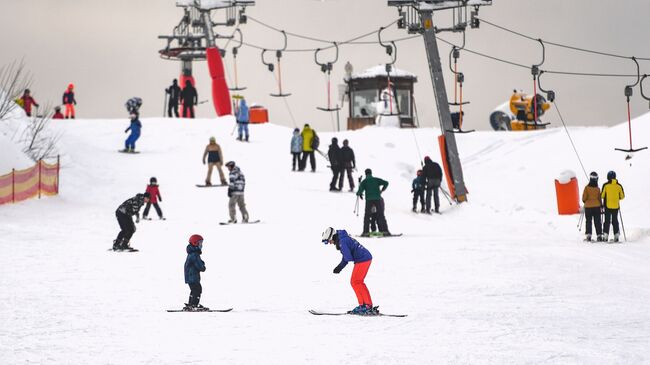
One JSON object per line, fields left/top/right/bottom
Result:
{"left": 0, "top": 156, "right": 60, "bottom": 205}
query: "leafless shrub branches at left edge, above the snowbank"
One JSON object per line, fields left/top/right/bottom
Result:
{"left": 0, "top": 60, "right": 32, "bottom": 121}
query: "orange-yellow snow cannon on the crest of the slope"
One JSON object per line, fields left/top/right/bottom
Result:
{"left": 490, "top": 90, "right": 551, "bottom": 131}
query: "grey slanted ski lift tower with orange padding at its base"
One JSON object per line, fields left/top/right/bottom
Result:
{"left": 388, "top": 0, "right": 492, "bottom": 203}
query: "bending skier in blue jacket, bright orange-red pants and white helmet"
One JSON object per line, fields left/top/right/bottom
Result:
{"left": 321, "top": 227, "right": 379, "bottom": 315}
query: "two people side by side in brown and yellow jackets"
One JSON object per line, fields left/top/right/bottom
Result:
{"left": 582, "top": 171, "right": 625, "bottom": 242}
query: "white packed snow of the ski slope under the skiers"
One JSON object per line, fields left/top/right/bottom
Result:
{"left": 0, "top": 116, "right": 650, "bottom": 364}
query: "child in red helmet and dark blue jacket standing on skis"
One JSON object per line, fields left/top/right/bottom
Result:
{"left": 183, "top": 234, "right": 210, "bottom": 312}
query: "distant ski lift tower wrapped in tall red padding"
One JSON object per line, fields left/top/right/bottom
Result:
{"left": 158, "top": 0, "right": 255, "bottom": 116}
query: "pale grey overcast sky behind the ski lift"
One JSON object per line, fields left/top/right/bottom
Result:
{"left": 0, "top": 0, "right": 650, "bottom": 130}
